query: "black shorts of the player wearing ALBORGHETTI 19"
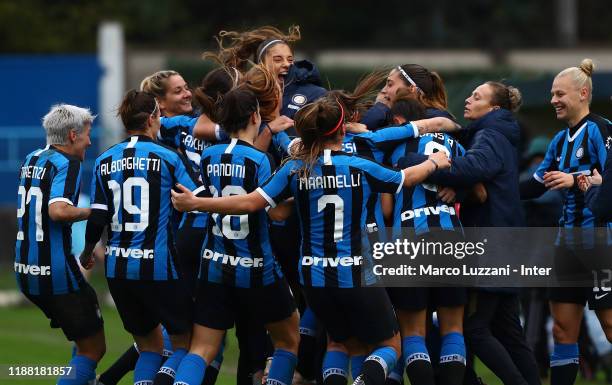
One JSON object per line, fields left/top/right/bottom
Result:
{"left": 107, "top": 278, "right": 193, "bottom": 336}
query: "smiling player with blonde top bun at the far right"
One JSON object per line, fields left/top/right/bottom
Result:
{"left": 521, "top": 59, "right": 612, "bottom": 385}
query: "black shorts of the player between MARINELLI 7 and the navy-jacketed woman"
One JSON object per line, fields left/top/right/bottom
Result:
{"left": 387, "top": 287, "right": 467, "bottom": 311}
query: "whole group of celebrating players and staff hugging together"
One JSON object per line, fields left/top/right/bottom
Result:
{"left": 14, "top": 27, "right": 612, "bottom": 385}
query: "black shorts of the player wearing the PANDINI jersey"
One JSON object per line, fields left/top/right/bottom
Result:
{"left": 194, "top": 279, "right": 296, "bottom": 330}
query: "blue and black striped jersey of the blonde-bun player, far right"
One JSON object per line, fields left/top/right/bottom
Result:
{"left": 533, "top": 114, "right": 612, "bottom": 228}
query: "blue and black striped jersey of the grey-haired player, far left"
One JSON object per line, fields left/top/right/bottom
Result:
{"left": 14, "top": 146, "right": 83, "bottom": 295}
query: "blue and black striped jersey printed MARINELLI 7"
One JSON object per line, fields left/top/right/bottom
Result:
{"left": 257, "top": 150, "right": 404, "bottom": 288}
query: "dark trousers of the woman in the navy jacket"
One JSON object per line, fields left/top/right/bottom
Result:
{"left": 464, "top": 290, "right": 540, "bottom": 385}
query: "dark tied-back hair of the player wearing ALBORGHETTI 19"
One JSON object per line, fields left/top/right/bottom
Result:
{"left": 117, "top": 89, "right": 159, "bottom": 131}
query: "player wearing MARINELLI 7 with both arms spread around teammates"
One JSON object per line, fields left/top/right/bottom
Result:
{"left": 173, "top": 92, "right": 449, "bottom": 385}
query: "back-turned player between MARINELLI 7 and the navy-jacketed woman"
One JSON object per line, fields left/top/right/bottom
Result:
{"left": 384, "top": 90, "right": 467, "bottom": 385}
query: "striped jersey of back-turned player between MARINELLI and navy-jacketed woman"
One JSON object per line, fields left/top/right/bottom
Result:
{"left": 391, "top": 133, "right": 465, "bottom": 235}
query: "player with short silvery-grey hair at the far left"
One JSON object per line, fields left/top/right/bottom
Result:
{"left": 14, "top": 104, "right": 106, "bottom": 385}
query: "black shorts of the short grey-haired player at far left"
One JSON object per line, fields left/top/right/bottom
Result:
{"left": 24, "top": 283, "right": 104, "bottom": 341}
